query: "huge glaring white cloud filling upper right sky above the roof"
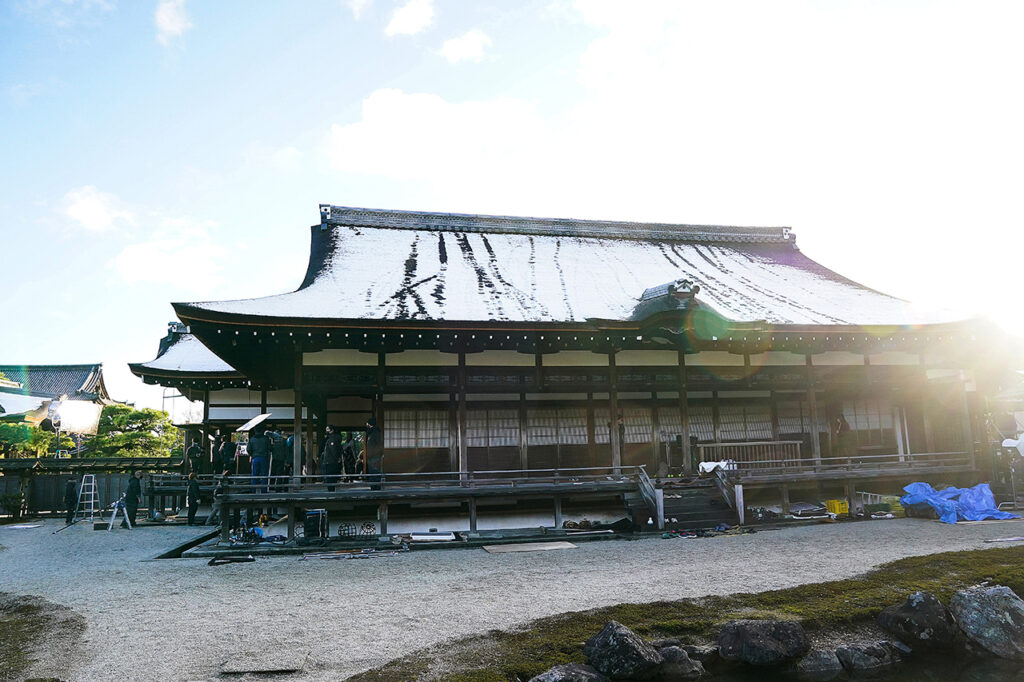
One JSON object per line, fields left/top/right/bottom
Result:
{"left": 327, "top": 0, "right": 1024, "bottom": 331}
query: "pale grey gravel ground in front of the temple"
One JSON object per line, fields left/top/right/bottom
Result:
{"left": 0, "top": 519, "right": 1024, "bottom": 682}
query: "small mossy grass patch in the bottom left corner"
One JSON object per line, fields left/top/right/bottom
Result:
{"left": 0, "top": 592, "right": 85, "bottom": 682}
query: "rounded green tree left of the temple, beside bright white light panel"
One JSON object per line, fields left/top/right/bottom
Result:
{"left": 91, "top": 404, "right": 178, "bottom": 457}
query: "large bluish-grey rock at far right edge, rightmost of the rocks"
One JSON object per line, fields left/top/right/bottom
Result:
{"left": 949, "top": 585, "right": 1024, "bottom": 660}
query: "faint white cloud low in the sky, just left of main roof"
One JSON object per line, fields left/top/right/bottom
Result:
{"left": 112, "top": 217, "right": 228, "bottom": 293}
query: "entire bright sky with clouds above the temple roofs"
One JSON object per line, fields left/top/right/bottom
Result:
{"left": 0, "top": 0, "right": 1024, "bottom": 411}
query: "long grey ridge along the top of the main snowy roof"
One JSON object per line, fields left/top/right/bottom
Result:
{"left": 319, "top": 204, "right": 796, "bottom": 245}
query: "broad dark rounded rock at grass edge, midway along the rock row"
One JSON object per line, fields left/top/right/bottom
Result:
{"left": 718, "top": 621, "right": 811, "bottom": 666}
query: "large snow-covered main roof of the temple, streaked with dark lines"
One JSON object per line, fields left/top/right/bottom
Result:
{"left": 175, "top": 206, "right": 964, "bottom": 326}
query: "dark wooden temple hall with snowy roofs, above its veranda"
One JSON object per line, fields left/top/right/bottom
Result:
{"left": 131, "top": 205, "right": 983, "bottom": 522}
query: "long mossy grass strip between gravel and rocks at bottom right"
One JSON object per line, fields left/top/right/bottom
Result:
{"left": 352, "top": 547, "right": 1024, "bottom": 682}
